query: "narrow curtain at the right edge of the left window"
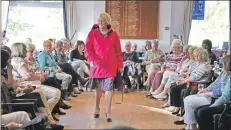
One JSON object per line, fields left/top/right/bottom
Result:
{"left": 63, "top": 0, "right": 78, "bottom": 45}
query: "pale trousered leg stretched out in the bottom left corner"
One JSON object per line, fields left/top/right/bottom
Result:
{"left": 1, "top": 111, "right": 31, "bottom": 125}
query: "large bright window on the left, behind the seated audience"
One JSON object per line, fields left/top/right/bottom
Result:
{"left": 7, "top": 1, "right": 65, "bottom": 49}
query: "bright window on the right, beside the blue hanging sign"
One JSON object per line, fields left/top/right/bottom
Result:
{"left": 189, "top": 1, "right": 230, "bottom": 48}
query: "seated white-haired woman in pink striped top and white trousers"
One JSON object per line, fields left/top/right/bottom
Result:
{"left": 152, "top": 39, "right": 184, "bottom": 99}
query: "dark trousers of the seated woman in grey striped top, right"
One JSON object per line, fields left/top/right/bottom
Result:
{"left": 170, "top": 83, "right": 187, "bottom": 107}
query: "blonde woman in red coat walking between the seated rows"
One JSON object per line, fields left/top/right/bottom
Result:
{"left": 85, "top": 13, "right": 123, "bottom": 122}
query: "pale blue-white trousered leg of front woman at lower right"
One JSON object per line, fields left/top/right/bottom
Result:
{"left": 184, "top": 95, "right": 210, "bottom": 129}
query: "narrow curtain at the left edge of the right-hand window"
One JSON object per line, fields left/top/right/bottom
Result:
{"left": 181, "top": 0, "right": 194, "bottom": 45}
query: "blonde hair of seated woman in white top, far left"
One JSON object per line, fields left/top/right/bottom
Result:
{"left": 11, "top": 42, "right": 27, "bottom": 57}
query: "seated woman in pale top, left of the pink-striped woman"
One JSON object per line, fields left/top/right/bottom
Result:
{"left": 143, "top": 39, "right": 165, "bottom": 83}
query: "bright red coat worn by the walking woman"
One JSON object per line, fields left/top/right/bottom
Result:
{"left": 85, "top": 24, "right": 123, "bottom": 78}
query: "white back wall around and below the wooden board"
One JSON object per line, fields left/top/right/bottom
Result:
{"left": 76, "top": 1, "right": 184, "bottom": 52}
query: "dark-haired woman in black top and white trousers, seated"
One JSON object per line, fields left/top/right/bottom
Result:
{"left": 70, "top": 40, "right": 90, "bottom": 78}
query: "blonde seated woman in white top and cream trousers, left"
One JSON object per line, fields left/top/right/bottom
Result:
{"left": 11, "top": 43, "right": 61, "bottom": 124}
